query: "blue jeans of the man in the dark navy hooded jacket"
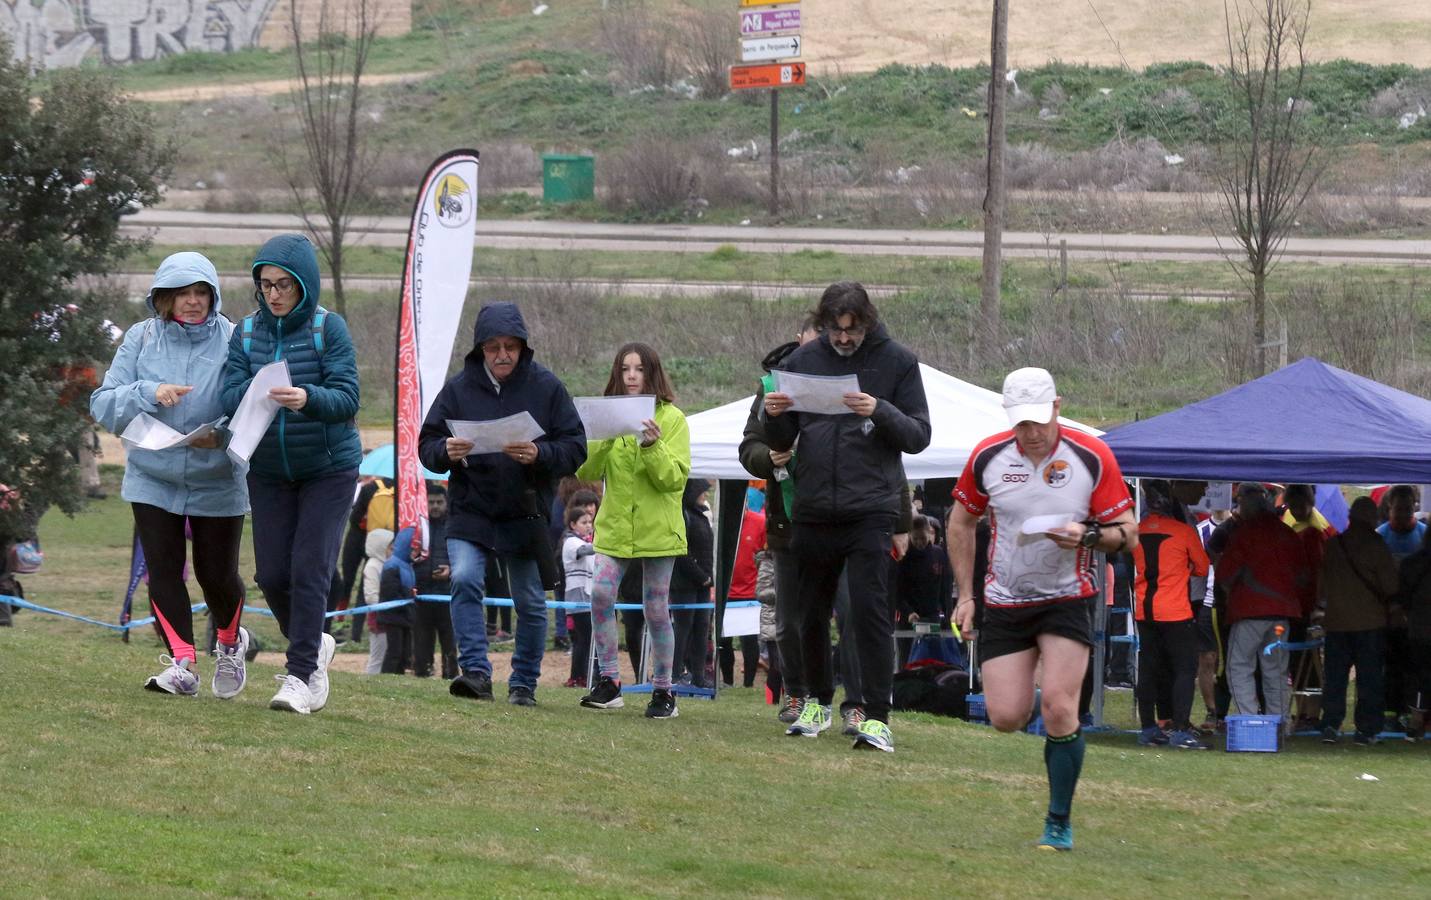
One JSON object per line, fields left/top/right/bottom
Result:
{"left": 448, "top": 538, "right": 547, "bottom": 691}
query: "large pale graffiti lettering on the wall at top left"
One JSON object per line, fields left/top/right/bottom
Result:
{"left": 0, "top": 0, "right": 278, "bottom": 69}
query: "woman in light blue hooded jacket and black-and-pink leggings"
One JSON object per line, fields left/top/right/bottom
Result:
{"left": 90, "top": 252, "right": 249, "bottom": 700}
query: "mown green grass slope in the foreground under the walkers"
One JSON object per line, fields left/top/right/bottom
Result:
{"left": 8, "top": 495, "right": 1431, "bottom": 897}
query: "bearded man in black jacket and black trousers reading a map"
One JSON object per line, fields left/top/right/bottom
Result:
{"left": 764, "top": 282, "right": 930, "bottom": 751}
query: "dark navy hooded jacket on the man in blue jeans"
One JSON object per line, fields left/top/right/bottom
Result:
{"left": 418, "top": 303, "right": 587, "bottom": 552}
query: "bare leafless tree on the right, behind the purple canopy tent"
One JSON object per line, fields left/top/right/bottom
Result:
{"left": 1213, "top": 0, "right": 1325, "bottom": 375}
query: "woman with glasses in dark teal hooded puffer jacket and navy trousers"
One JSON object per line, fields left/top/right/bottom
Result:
{"left": 223, "top": 235, "right": 362, "bottom": 714}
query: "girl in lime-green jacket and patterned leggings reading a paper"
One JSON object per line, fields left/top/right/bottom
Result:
{"left": 577, "top": 343, "right": 691, "bottom": 718}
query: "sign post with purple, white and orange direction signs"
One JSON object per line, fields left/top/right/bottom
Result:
{"left": 730, "top": 0, "right": 806, "bottom": 217}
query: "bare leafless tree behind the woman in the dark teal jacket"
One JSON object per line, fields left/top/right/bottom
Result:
{"left": 278, "top": 0, "right": 378, "bottom": 313}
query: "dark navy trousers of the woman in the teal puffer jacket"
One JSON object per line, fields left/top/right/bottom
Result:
{"left": 248, "top": 469, "right": 358, "bottom": 681}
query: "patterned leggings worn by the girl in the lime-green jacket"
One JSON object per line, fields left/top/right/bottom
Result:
{"left": 591, "top": 554, "right": 675, "bottom": 691}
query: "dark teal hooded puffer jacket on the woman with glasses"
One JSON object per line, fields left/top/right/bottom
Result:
{"left": 223, "top": 235, "right": 362, "bottom": 481}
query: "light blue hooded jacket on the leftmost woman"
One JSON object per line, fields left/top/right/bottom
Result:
{"left": 90, "top": 252, "right": 249, "bottom": 517}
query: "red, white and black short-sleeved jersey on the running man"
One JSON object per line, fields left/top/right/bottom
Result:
{"left": 953, "top": 428, "right": 1133, "bottom": 608}
